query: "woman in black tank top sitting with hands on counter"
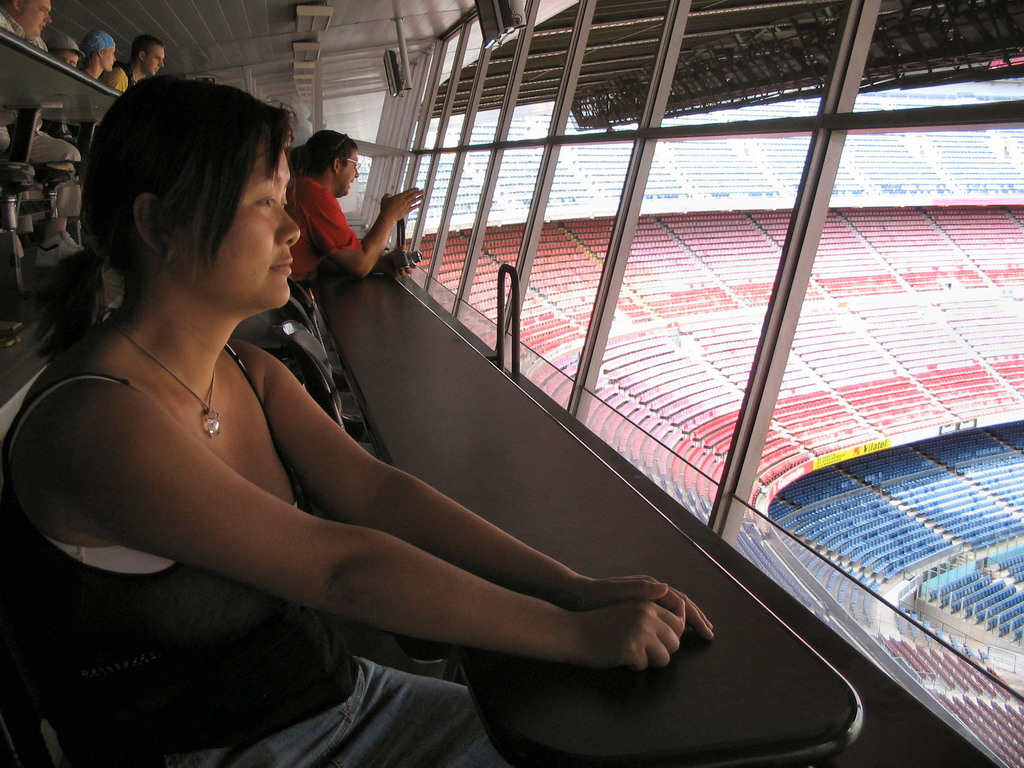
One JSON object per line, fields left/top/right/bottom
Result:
{"left": 0, "top": 78, "right": 712, "bottom": 768}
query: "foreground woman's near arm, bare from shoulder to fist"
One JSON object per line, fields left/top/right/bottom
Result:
{"left": 13, "top": 354, "right": 704, "bottom": 668}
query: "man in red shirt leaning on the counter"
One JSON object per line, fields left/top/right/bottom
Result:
{"left": 286, "top": 130, "right": 423, "bottom": 282}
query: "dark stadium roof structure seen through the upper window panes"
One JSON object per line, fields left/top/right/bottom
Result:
{"left": 437, "top": 0, "right": 1024, "bottom": 129}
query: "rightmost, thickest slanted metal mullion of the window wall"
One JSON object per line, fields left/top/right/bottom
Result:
{"left": 709, "top": 0, "right": 881, "bottom": 544}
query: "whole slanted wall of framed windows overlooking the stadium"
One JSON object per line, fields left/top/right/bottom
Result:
{"left": 405, "top": 0, "right": 1024, "bottom": 763}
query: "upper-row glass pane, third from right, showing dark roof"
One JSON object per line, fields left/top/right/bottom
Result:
{"left": 565, "top": 0, "right": 669, "bottom": 133}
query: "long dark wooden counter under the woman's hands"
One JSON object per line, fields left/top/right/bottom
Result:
{"left": 319, "top": 278, "right": 991, "bottom": 768}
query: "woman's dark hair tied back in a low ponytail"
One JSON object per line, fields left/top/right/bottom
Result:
{"left": 40, "top": 77, "right": 293, "bottom": 355}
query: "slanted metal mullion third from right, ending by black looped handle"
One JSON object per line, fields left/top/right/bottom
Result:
{"left": 516, "top": 0, "right": 597, "bottom": 294}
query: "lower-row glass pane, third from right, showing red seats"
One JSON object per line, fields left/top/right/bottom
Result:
{"left": 522, "top": 143, "right": 632, "bottom": 376}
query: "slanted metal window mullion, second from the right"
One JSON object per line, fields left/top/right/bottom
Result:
{"left": 567, "top": 0, "right": 691, "bottom": 417}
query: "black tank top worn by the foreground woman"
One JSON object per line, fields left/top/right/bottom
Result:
{"left": 0, "top": 354, "right": 354, "bottom": 768}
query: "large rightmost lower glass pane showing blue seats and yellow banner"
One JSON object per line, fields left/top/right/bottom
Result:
{"left": 765, "top": 130, "right": 1024, "bottom": 756}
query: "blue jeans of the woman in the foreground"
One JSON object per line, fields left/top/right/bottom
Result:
{"left": 164, "top": 658, "right": 508, "bottom": 768}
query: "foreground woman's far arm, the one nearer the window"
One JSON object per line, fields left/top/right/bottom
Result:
{"left": 248, "top": 344, "right": 712, "bottom": 637}
